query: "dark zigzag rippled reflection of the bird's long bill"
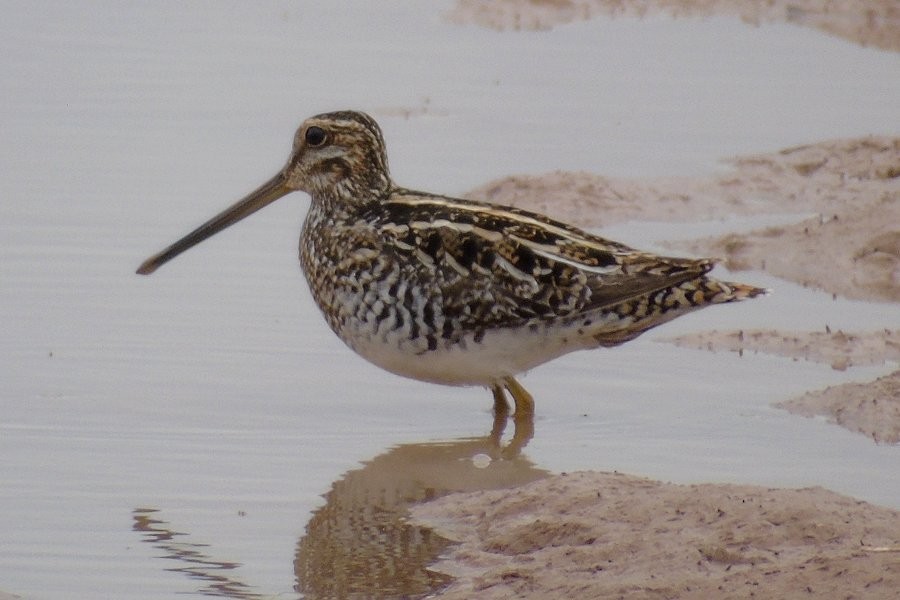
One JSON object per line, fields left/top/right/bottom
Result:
{"left": 132, "top": 508, "right": 265, "bottom": 600}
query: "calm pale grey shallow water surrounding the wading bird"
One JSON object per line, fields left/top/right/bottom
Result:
{"left": 0, "top": 2, "right": 900, "bottom": 598}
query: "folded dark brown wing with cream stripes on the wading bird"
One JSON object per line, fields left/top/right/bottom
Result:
{"left": 372, "top": 190, "right": 713, "bottom": 326}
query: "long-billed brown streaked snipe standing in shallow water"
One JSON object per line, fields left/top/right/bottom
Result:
{"left": 137, "top": 110, "right": 768, "bottom": 418}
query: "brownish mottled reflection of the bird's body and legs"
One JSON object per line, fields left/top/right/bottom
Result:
{"left": 294, "top": 411, "right": 546, "bottom": 600}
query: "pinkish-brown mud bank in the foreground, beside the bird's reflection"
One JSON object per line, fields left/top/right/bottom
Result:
{"left": 413, "top": 472, "right": 900, "bottom": 600}
